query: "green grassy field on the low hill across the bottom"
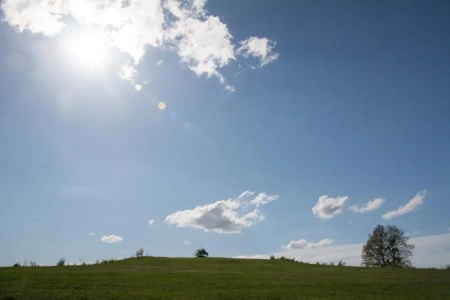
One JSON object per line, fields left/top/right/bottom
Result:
{"left": 0, "top": 257, "right": 450, "bottom": 300}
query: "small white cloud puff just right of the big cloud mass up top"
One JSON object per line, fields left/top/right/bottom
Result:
{"left": 237, "top": 36, "right": 279, "bottom": 67}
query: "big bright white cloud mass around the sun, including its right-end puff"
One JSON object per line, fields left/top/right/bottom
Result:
{"left": 1, "top": 0, "right": 278, "bottom": 90}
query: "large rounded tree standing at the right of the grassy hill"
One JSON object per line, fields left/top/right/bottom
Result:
{"left": 361, "top": 225, "right": 414, "bottom": 268}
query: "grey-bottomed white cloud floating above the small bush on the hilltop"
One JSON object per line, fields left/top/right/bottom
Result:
{"left": 165, "top": 191, "right": 278, "bottom": 233}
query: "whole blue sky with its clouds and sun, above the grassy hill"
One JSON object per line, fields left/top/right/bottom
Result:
{"left": 0, "top": 0, "right": 450, "bottom": 267}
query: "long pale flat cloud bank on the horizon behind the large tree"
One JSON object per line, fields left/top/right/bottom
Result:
{"left": 235, "top": 233, "right": 450, "bottom": 268}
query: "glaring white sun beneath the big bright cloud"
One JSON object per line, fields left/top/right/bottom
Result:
{"left": 64, "top": 32, "right": 109, "bottom": 68}
